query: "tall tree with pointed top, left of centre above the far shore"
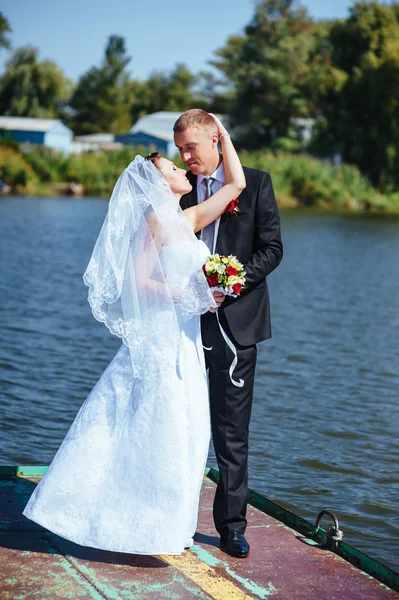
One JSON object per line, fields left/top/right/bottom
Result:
{"left": 69, "top": 35, "right": 132, "bottom": 134}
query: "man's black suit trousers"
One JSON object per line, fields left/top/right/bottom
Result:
{"left": 202, "top": 311, "right": 257, "bottom": 536}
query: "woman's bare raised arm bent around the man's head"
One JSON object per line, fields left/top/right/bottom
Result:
{"left": 184, "top": 115, "right": 246, "bottom": 231}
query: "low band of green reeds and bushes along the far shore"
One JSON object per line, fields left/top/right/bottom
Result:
{"left": 0, "top": 145, "right": 399, "bottom": 212}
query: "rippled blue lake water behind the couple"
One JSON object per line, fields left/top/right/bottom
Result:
{"left": 0, "top": 197, "right": 399, "bottom": 570}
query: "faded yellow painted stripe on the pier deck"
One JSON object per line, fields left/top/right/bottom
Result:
{"left": 159, "top": 551, "right": 253, "bottom": 600}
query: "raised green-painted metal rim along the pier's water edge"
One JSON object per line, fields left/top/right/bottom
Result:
{"left": 0, "top": 465, "right": 399, "bottom": 592}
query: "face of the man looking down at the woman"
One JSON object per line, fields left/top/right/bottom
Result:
{"left": 174, "top": 127, "right": 219, "bottom": 175}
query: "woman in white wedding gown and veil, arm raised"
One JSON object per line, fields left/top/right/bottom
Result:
{"left": 23, "top": 118, "right": 245, "bottom": 554}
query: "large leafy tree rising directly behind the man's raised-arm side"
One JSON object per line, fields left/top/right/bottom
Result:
{"left": 212, "top": 0, "right": 336, "bottom": 145}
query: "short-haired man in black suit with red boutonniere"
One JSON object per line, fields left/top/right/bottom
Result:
{"left": 173, "top": 109, "right": 283, "bottom": 558}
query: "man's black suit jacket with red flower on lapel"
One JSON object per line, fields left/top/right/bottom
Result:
{"left": 180, "top": 167, "right": 283, "bottom": 346}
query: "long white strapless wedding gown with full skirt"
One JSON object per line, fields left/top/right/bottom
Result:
{"left": 23, "top": 239, "right": 211, "bottom": 554}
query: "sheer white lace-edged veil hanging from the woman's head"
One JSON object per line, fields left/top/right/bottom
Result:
{"left": 83, "top": 156, "right": 216, "bottom": 379}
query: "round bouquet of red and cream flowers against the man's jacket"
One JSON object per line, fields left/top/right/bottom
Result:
{"left": 202, "top": 254, "right": 246, "bottom": 298}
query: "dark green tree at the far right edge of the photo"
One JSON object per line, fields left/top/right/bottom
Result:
{"left": 326, "top": 2, "right": 399, "bottom": 189}
